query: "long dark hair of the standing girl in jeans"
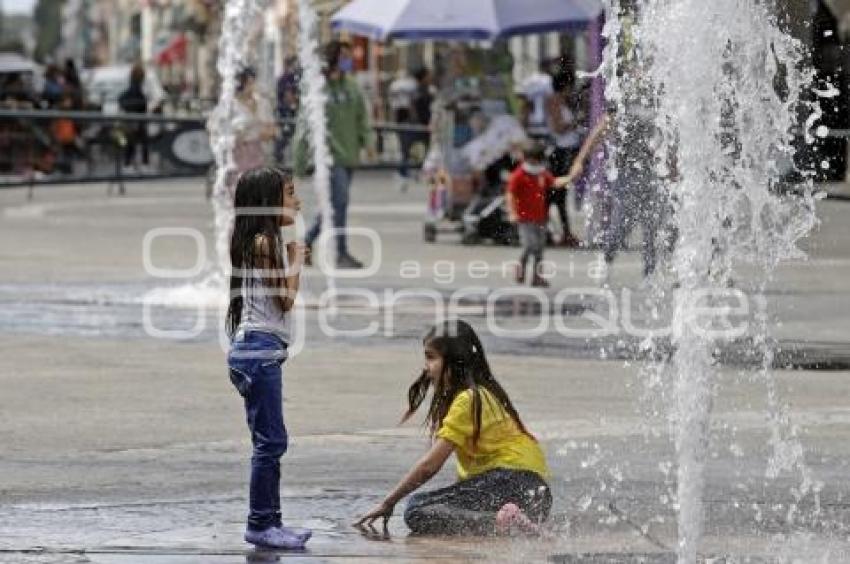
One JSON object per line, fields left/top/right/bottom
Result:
{"left": 225, "top": 167, "right": 292, "bottom": 337}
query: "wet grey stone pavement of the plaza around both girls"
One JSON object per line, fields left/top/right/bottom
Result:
{"left": 0, "top": 175, "right": 850, "bottom": 564}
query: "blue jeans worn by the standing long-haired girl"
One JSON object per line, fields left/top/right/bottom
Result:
{"left": 227, "top": 331, "right": 288, "bottom": 531}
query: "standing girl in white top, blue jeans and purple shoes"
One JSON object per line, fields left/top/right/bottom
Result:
{"left": 226, "top": 168, "right": 311, "bottom": 549}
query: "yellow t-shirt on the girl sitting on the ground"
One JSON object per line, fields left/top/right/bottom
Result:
{"left": 437, "top": 388, "right": 549, "bottom": 480}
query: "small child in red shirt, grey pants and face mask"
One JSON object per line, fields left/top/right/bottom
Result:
{"left": 506, "top": 143, "right": 569, "bottom": 288}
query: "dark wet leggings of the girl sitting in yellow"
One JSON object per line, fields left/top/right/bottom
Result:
{"left": 404, "top": 469, "right": 552, "bottom": 535}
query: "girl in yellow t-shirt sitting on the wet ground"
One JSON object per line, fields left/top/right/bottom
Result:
{"left": 355, "top": 321, "right": 552, "bottom": 535}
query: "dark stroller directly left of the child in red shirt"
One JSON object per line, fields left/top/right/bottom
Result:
{"left": 461, "top": 153, "right": 519, "bottom": 245}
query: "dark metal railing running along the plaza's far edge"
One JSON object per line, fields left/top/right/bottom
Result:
{"left": 0, "top": 109, "right": 428, "bottom": 193}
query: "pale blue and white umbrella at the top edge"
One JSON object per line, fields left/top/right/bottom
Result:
{"left": 331, "top": 0, "right": 602, "bottom": 41}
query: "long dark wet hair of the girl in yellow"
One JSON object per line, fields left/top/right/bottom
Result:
{"left": 402, "top": 320, "right": 534, "bottom": 447}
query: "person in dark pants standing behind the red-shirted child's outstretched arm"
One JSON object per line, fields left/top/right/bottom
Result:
{"left": 546, "top": 69, "right": 587, "bottom": 247}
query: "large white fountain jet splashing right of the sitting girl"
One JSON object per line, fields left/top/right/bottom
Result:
{"left": 605, "top": 0, "right": 815, "bottom": 563}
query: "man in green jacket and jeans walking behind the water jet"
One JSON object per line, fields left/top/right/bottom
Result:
{"left": 295, "top": 41, "right": 369, "bottom": 268}
